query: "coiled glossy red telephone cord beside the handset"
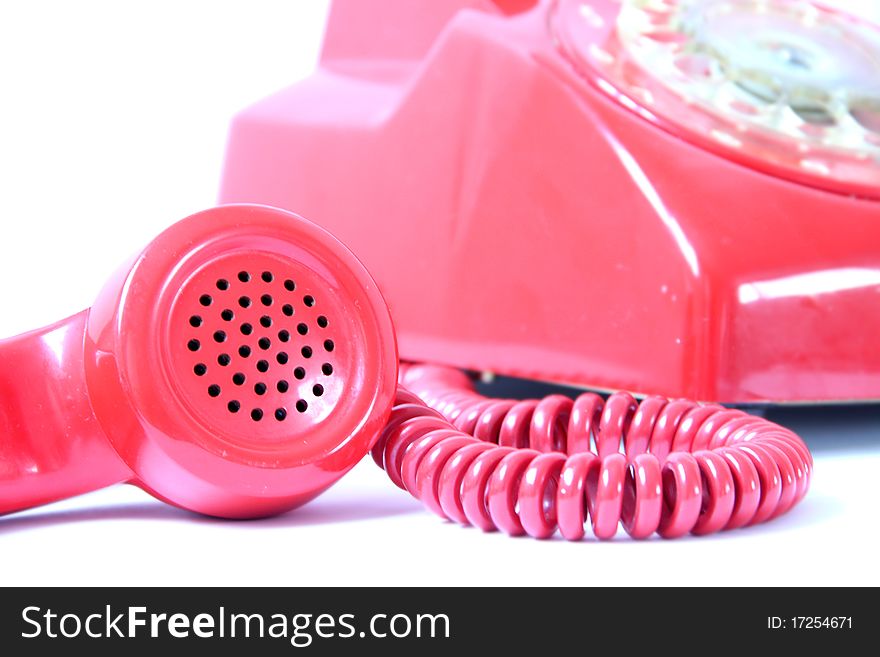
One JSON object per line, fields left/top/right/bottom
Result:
{"left": 373, "top": 365, "right": 813, "bottom": 540}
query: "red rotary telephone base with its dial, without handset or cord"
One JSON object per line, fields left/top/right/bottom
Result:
{"left": 220, "top": 0, "right": 880, "bottom": 403}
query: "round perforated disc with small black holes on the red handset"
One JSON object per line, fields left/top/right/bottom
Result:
{"left": 173, "top": 256, "right": 340, "bottom": 435}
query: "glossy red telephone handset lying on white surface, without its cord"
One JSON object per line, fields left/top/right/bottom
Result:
{"left": 0, "top": 205, "right": 398, "bottom": 518}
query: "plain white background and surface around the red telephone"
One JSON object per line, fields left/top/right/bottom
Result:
{"left": 0, "top": 0, "right": 880, "bottom": 585}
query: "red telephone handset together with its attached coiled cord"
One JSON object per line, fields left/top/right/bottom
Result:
{"left": 0, "top": 205, "right": 812, "bottom": 540}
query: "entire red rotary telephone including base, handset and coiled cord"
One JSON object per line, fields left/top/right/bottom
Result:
{"left": 8, "top": 0, "right": 880, "bottom": 539}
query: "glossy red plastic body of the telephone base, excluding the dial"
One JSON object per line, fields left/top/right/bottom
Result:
{"left": 220, "top": 0, "right": 880, "bottom": 402}
